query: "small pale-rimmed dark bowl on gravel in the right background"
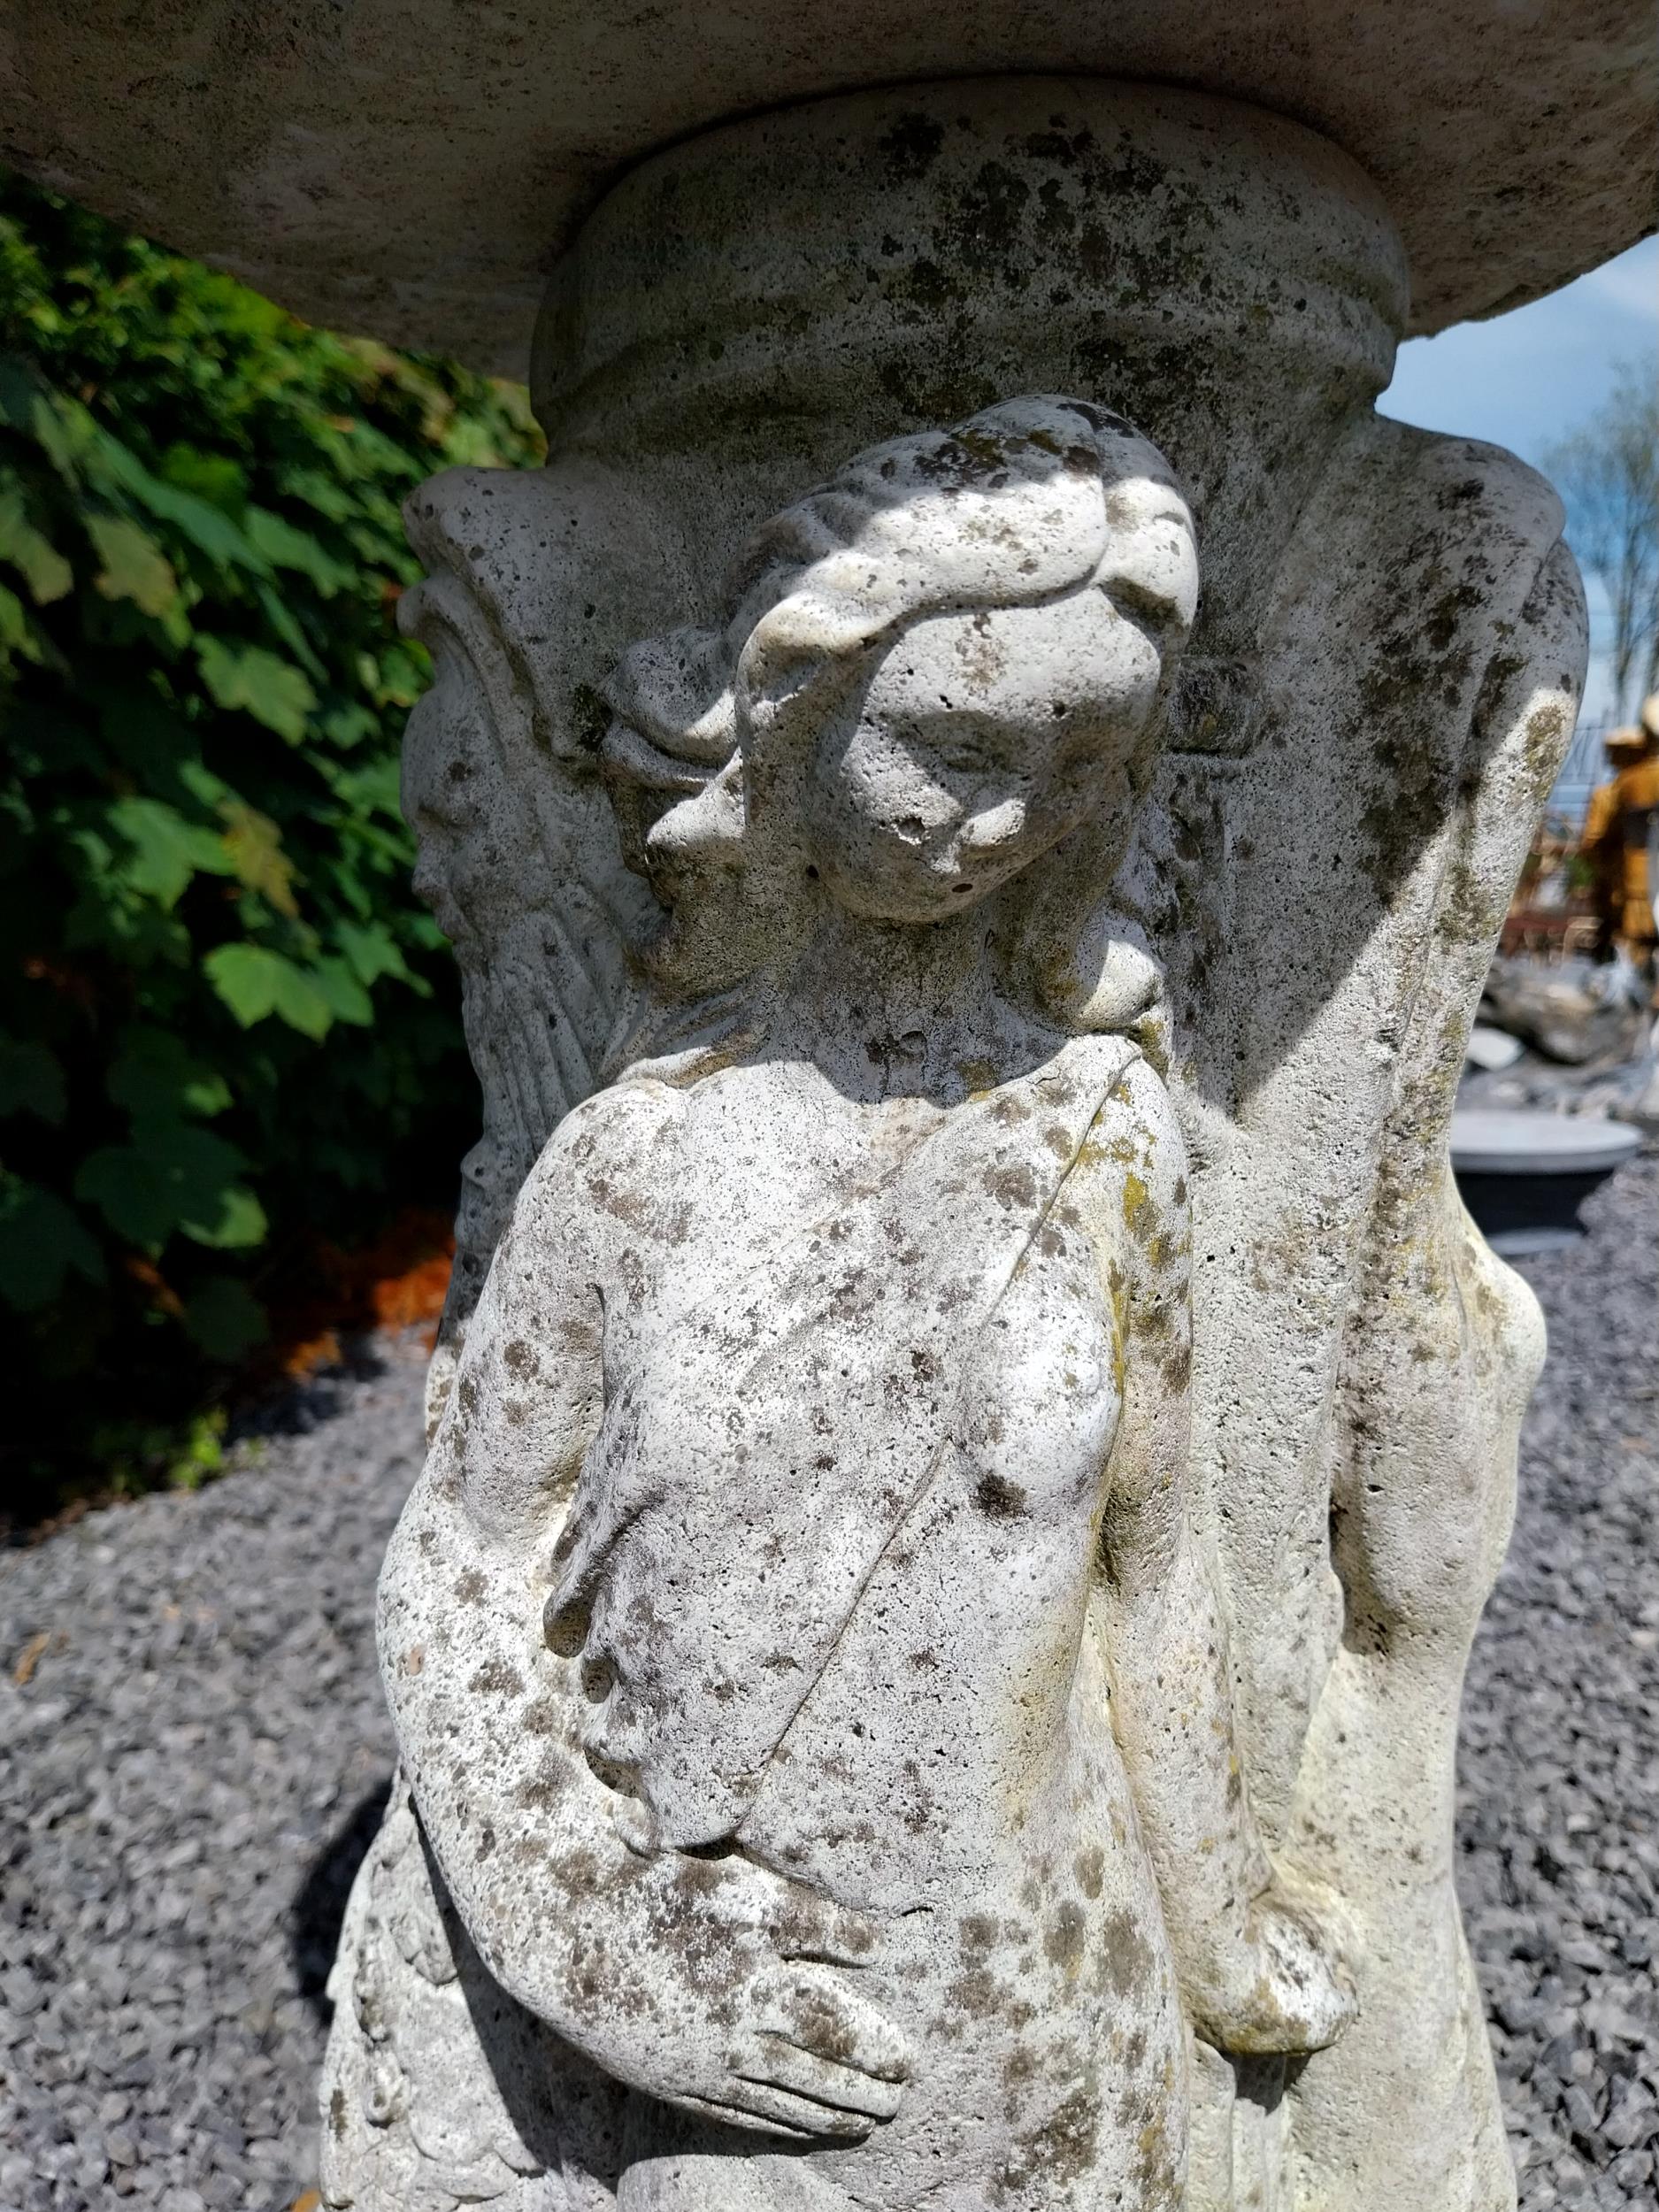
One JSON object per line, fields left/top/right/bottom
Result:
{"left": 1451, "top": 1110, "right": 1641, "bottom": 1259}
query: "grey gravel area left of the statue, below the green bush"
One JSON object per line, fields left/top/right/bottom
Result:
{"left": 0, "top": 1340, "right": 425, "bottom": 2212}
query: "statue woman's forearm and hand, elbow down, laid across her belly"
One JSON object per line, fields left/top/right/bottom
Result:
{"left": 380, "top": 1469, "right": 910, "bottom": 2141}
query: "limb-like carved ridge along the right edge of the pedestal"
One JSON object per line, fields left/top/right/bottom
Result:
{"left": 1332, "top": 526, "right": 1600, "bottom": 1655}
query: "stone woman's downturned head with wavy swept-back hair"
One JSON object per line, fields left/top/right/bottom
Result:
{"left": 606, "top": 398, "right": 1199, "bottom": 991}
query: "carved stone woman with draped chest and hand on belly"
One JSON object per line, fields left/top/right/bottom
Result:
{"left": 351, "top": 401, "right": 1349, "bottom": 2212}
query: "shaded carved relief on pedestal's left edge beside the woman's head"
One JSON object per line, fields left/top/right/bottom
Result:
{"left": 401, "top": 467, "right": 671, "bottom": 1423}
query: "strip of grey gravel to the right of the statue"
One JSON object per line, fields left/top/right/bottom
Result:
{"left": 1458, "top": 1150, "right": 1659, "bottom": 2212}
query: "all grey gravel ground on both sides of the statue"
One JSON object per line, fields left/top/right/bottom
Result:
{"left": 0, "top": 1157, "right": 1659, "bottom": 2212}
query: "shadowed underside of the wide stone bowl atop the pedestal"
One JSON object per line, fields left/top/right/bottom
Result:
{"left": 0, "top": 0, "right": 1659, "bottom": 369}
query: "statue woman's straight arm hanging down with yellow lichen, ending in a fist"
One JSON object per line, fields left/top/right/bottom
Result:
{"left": 1091, "top": 1062, "right": 1352, "bottom": 2053}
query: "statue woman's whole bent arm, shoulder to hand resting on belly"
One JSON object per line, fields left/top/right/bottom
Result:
{"left": 379, "top": 1106, "right": 905, "bottom": 2137}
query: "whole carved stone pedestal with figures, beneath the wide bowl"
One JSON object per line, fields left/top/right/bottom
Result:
{"left": 311, "top": 82, "right": 1584, "bottom": 2212}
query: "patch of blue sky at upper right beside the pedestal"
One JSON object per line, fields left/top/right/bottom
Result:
{"left": 1379, "top": 239, "right": 1659, "bottom": 721}
